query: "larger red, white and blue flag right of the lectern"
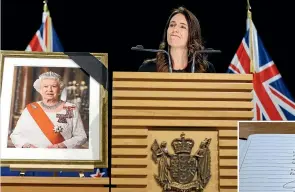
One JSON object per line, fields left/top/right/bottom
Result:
{"left": 227, "top": 13, "right": 295, "bottom": 121}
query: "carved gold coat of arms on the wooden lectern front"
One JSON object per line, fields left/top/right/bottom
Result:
{"left": 151, "top": 133, "right": 211, "bottom": 192}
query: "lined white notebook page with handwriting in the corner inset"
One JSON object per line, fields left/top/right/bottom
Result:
{"left": 239, "top": 134, "right": 295, "bottom": 192}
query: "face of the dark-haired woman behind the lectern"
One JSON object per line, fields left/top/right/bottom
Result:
{"left": 167, "top": 13, "right": 188, "bottom": 48}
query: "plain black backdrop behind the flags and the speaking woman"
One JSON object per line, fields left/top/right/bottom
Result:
{"left": 1, "top": 0, "right": 295, "bottom": 97}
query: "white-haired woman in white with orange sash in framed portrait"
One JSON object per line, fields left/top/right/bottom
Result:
{"left": 9, "top": 71, "right": 87, "bottom": 149}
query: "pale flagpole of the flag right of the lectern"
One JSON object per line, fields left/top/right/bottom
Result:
{"left": 247, "top": 0, "right": 255, "bottom": 73}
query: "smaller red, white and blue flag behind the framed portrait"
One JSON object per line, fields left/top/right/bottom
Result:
{"left": 26, "top": 3, "right": 64, "bottom": 52}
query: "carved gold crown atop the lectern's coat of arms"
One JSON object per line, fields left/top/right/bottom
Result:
{"left": 171, "top": 133, "right": 195, "bottom": 154}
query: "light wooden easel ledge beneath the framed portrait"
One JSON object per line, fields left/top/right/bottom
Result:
{"left": 9, "top": 164, "right": 95, "bottom": 178}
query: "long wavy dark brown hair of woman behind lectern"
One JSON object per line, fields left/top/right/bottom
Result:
{"left": 156, "top": 7, "right": 208, "bottom": 73}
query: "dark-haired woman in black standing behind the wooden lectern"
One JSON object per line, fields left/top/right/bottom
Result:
{"left": 139, "top": 7, "right": 215, "bottom": 73}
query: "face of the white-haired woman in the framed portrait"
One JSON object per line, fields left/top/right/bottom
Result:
{"left": 41, "top": 79, "right": 60, "bottom": 100}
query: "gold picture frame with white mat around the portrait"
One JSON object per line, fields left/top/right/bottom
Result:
{"left": 0, "top": 51, "right": 108, "bottom": 168}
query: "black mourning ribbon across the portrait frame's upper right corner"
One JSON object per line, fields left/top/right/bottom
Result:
{"left": 64, "top": 52, "right": 108, "bottom": 90}
